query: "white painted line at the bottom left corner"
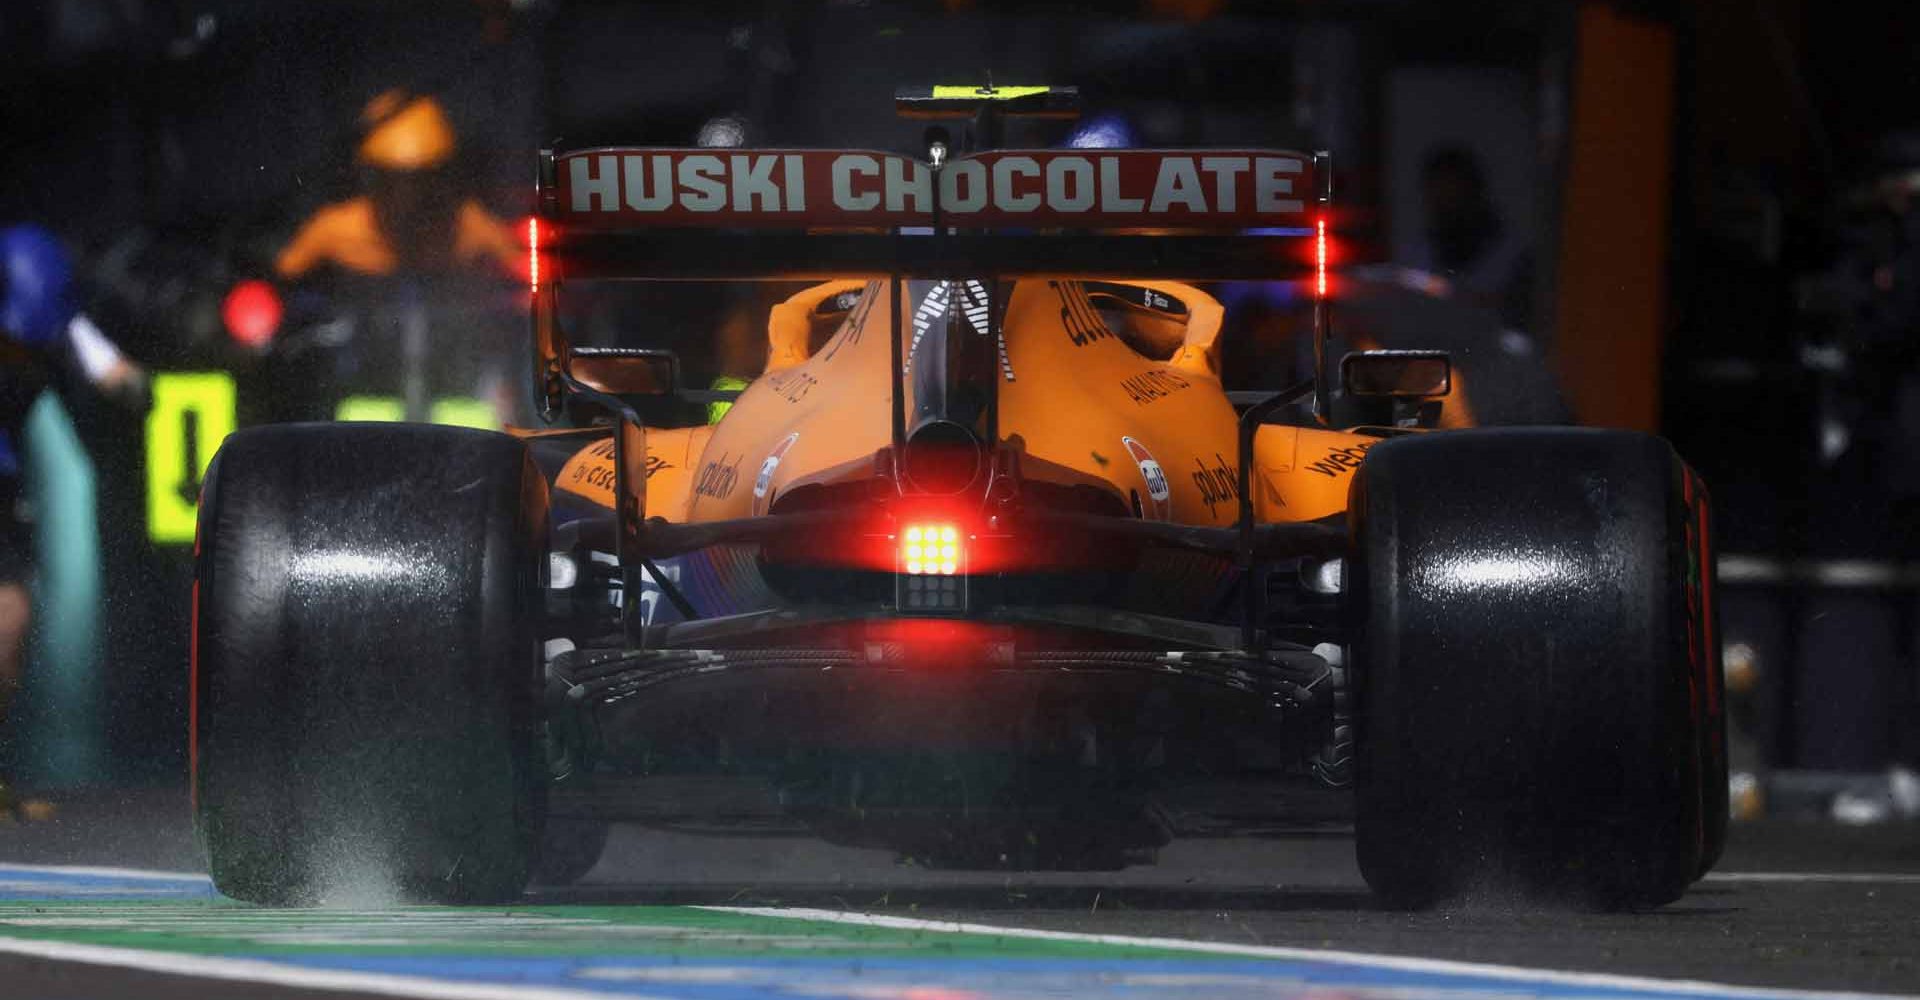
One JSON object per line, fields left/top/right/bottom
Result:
{"left": 0, "top": 937, "right": 666, "bottom": 1000}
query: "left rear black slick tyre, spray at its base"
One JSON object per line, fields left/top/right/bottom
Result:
{"left": 190, "top": 424, "right": 547, "bottom": 904}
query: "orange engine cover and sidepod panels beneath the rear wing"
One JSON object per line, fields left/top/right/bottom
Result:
{"left": 557, "top": 278, "right": 1380, "bottom": 526}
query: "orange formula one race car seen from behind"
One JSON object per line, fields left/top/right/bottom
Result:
{"left": 192, "top": 88, "right": 1726, "bottom": 906}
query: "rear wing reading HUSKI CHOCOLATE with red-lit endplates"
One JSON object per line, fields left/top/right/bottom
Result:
{"left": 528, "top": 146, "right": 1332, "bottom": 418}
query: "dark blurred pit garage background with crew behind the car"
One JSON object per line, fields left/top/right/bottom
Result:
{"left": 0, "top": 0, "right": 1920, "bottom": 823}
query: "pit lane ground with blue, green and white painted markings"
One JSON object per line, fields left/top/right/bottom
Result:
{"left": 0, "top": 791, "right": 1920, "bottom": 1000}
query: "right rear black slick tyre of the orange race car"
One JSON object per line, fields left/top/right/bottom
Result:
{"left": 1348, "top": 428, "right": 1724, "bottom": 908}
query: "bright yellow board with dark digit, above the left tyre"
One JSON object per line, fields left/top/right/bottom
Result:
{"left": 146, "top": 372, "right": 236, "bottom": 543}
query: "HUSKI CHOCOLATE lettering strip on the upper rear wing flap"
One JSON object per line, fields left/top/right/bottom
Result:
{"left": 555, "top": 150, "right": 1311, "bottom": 226}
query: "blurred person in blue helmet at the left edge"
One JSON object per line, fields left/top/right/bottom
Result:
{"left": 0, "top": 225, "right": 146, "bottom": 820}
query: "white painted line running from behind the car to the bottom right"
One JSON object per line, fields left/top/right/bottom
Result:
{"left": 695, "top": 906, "right": 1901, "bottom": 1000}
